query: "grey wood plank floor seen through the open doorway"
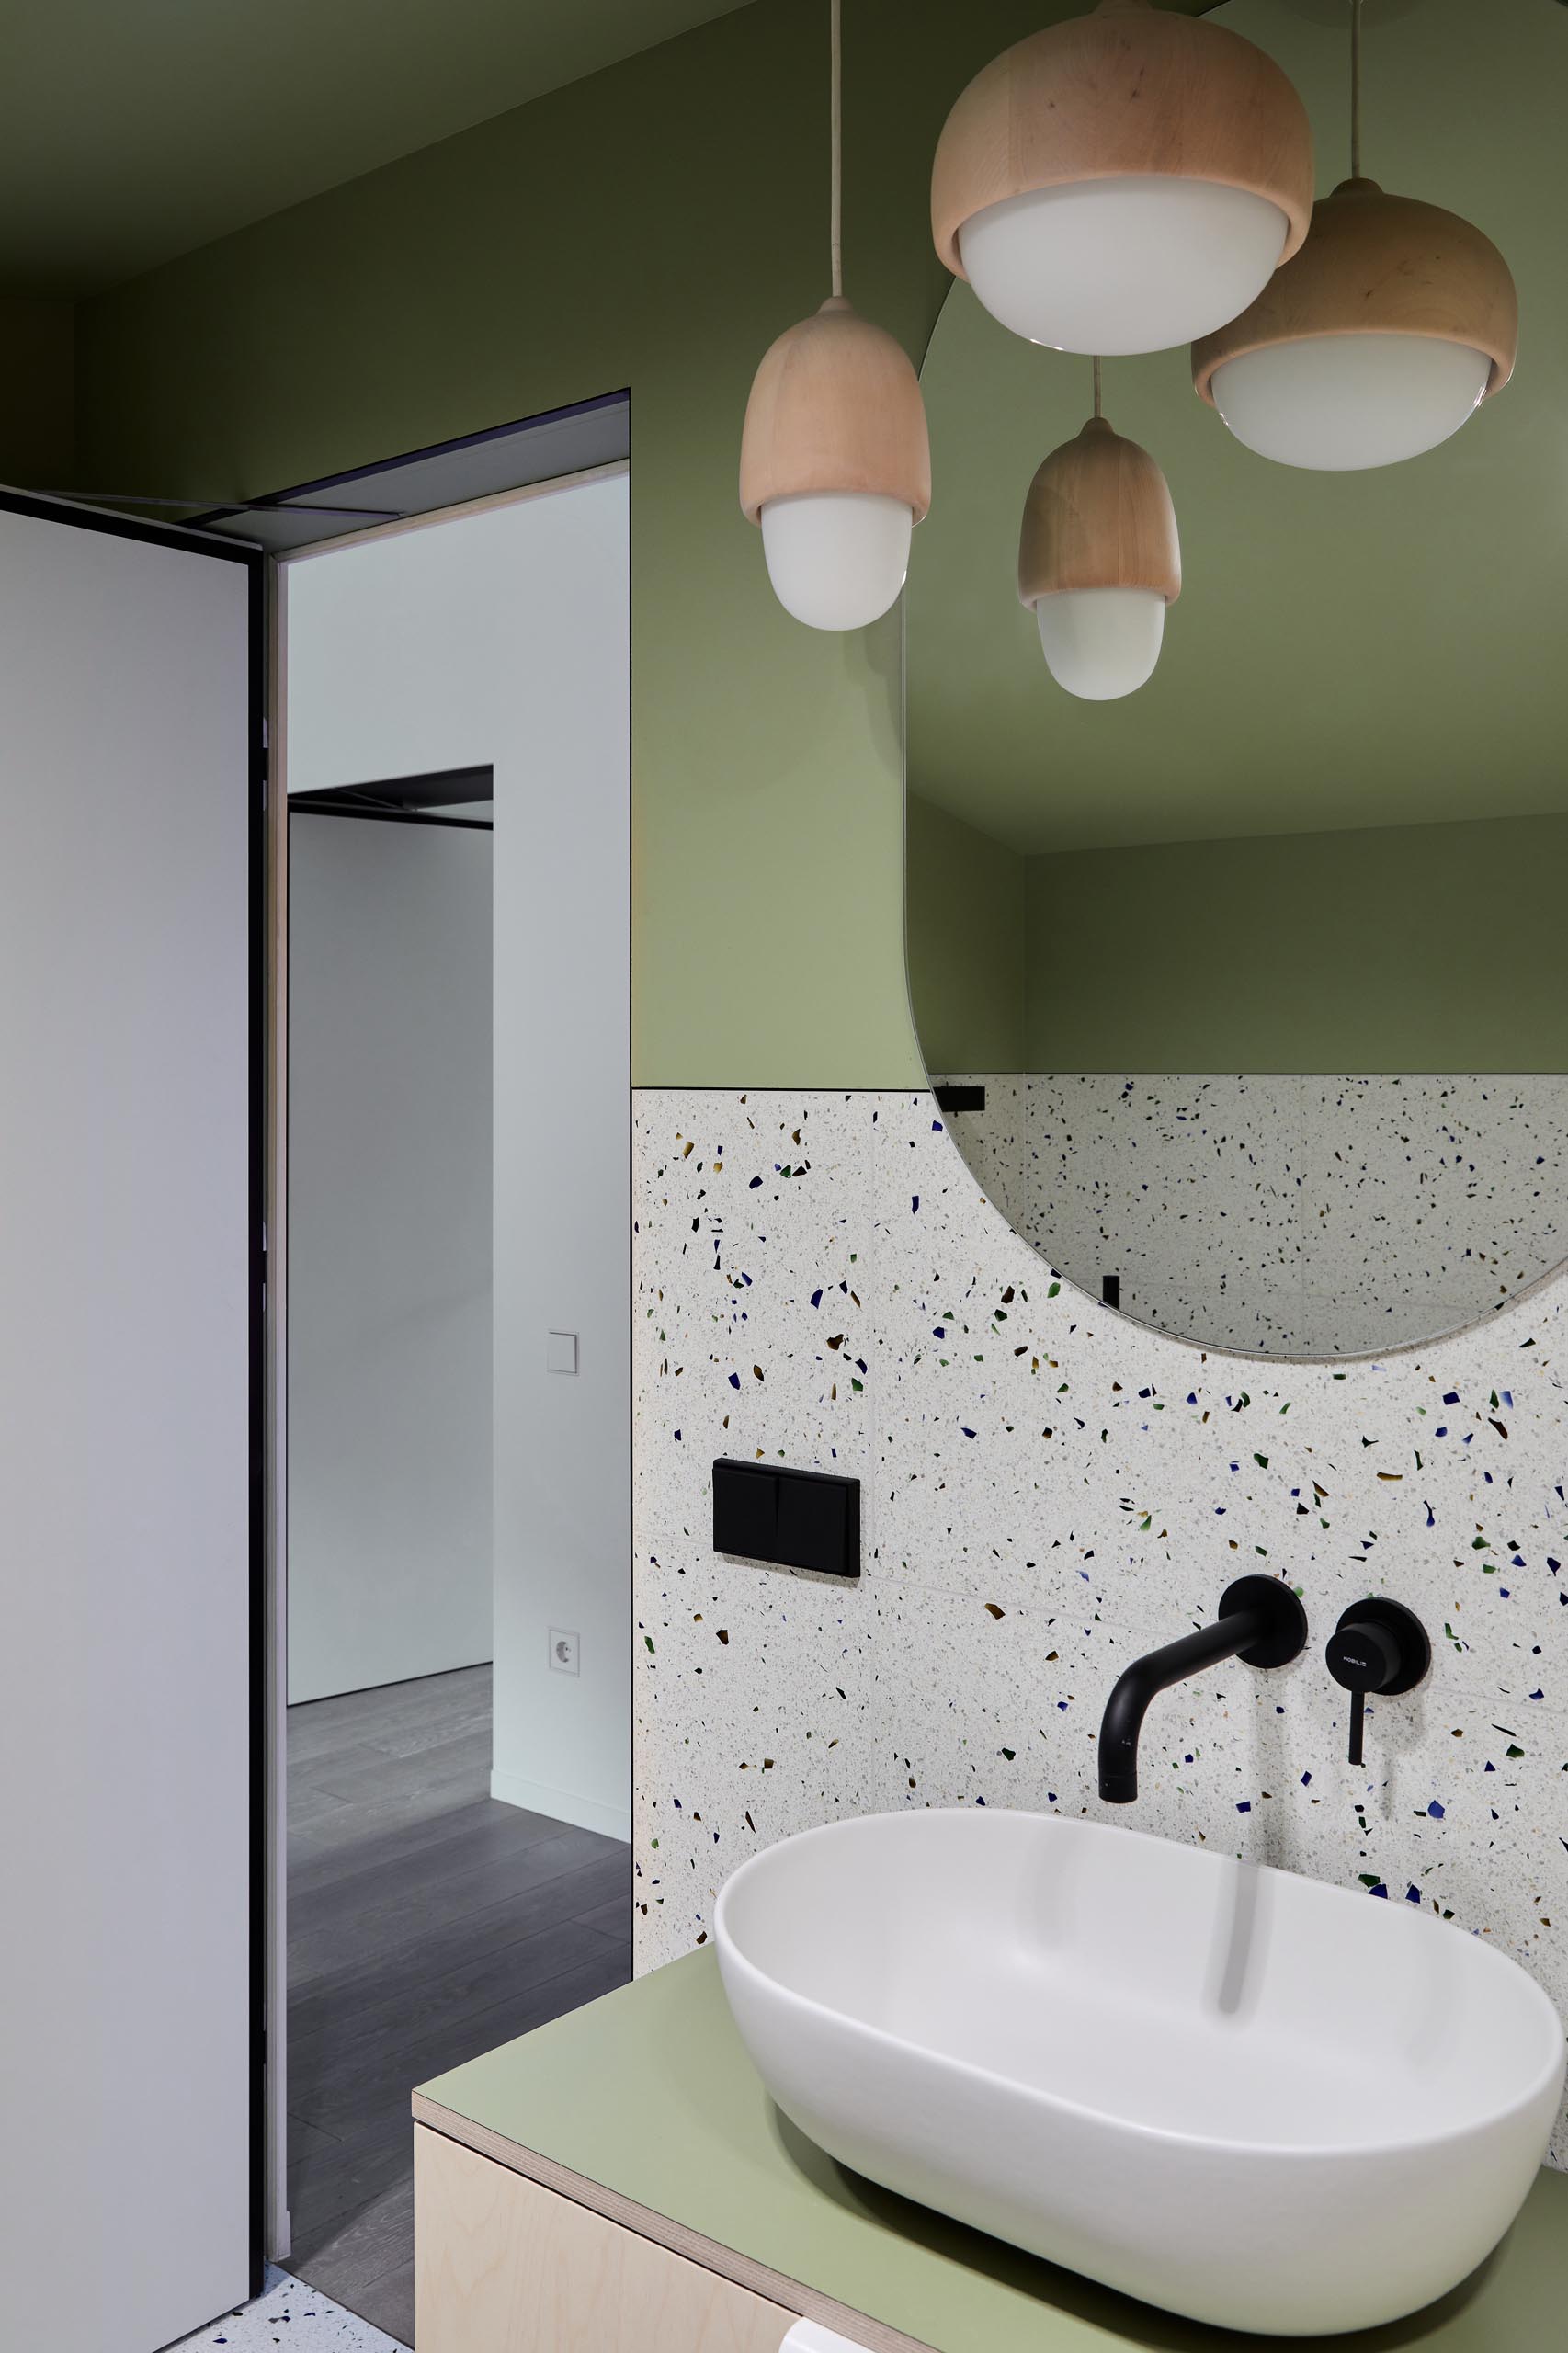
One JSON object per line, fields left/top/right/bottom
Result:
{"left": 288, "top": 1665, "right": 631, "bottom": 2346}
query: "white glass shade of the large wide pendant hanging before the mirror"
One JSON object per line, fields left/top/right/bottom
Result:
{"left": 959, "top": 176, "right": 1290, "bottom": 358}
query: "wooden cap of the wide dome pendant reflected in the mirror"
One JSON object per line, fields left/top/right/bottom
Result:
{"left": 1191, "top": 179, "right": 1518, "bottom": 407}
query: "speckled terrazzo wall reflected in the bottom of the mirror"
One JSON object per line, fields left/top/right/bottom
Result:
{"left": 927, "top": 1071, "right": 1568, "bottom": 1356}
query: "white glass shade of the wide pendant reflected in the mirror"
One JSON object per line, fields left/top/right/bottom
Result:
{"left": 1210, "top": 335, "right": 1493, "bottom": 473}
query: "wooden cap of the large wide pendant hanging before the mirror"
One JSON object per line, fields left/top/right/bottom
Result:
{"left": 930, "top": 0, "right": 1313, "bottom": 278}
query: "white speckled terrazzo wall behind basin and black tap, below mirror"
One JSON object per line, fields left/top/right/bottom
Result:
{"left": 633, "top": 1089, "right": 1568, "bottom": 2165}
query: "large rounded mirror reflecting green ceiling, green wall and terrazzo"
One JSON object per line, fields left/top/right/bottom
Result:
{"left": 906, "top": 0, "right": 1568, "bottom": 1358}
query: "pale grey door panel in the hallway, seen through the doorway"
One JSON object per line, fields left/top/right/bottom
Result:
{"left": 290, "top": 809, "right": 492, "bottom": 1703}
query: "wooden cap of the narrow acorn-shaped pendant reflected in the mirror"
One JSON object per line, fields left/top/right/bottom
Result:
{"left": 1017, "top": 416, "right": 1182, "bottom": 605}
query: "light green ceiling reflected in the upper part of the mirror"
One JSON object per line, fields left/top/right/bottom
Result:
{"left": 906, "top": 0, "right": 1568, "bottom": 849}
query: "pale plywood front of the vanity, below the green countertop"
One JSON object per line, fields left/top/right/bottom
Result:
{"left": 415, "top": 2125, "right": 796, "bottom": 2353}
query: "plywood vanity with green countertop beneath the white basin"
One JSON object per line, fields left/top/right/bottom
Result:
{"left": 415, "top": 1950, "right": 1568, "bottom": 2353}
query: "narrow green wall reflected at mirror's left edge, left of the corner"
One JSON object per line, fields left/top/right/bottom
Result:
{"left": 906, "top": 793, "right": 1028, "bottom": 1071}
